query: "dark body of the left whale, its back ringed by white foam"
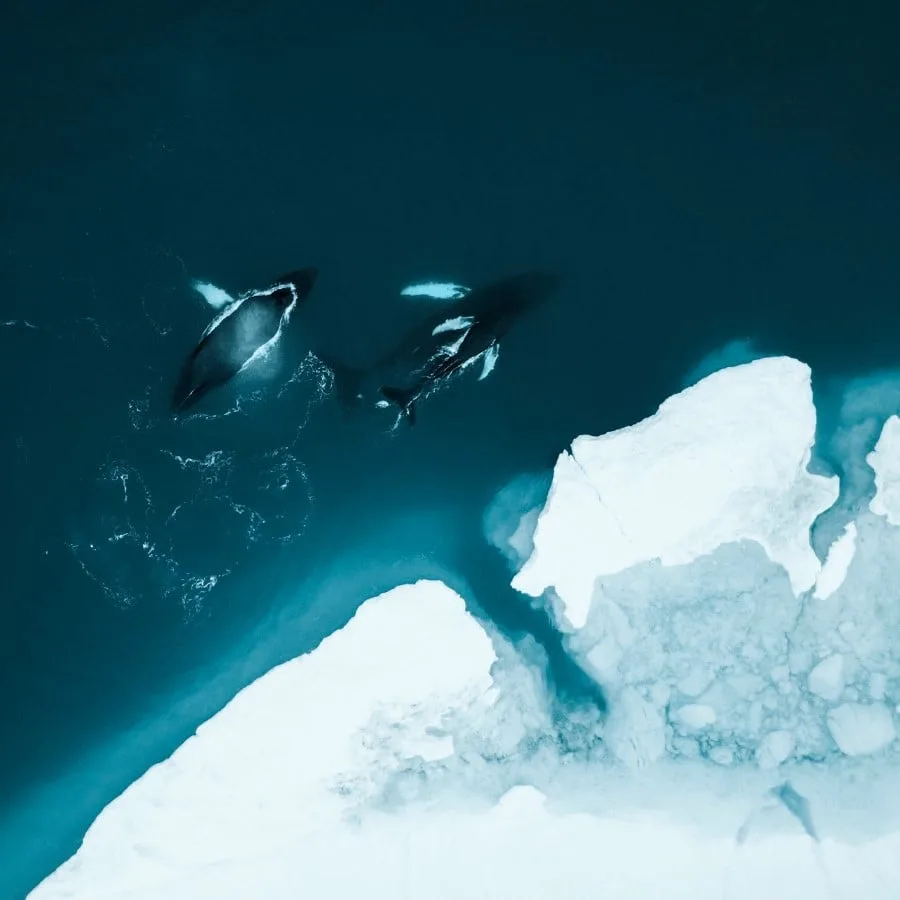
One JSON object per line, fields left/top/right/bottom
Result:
{"left": 172, "top": 267, "right": 318, "bottom": 415}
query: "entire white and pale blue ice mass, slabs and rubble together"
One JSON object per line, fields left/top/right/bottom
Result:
{"left": 31, "top": 359, "right": 900, "bottom": 900}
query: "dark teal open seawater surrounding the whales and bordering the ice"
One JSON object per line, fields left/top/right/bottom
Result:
{"left": 0, "top": 0, "right": 900, "bottom": 897}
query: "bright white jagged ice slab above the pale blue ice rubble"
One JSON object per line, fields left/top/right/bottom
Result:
{"left": 514, "top": 358, "right": 838, "bottom": 628}
